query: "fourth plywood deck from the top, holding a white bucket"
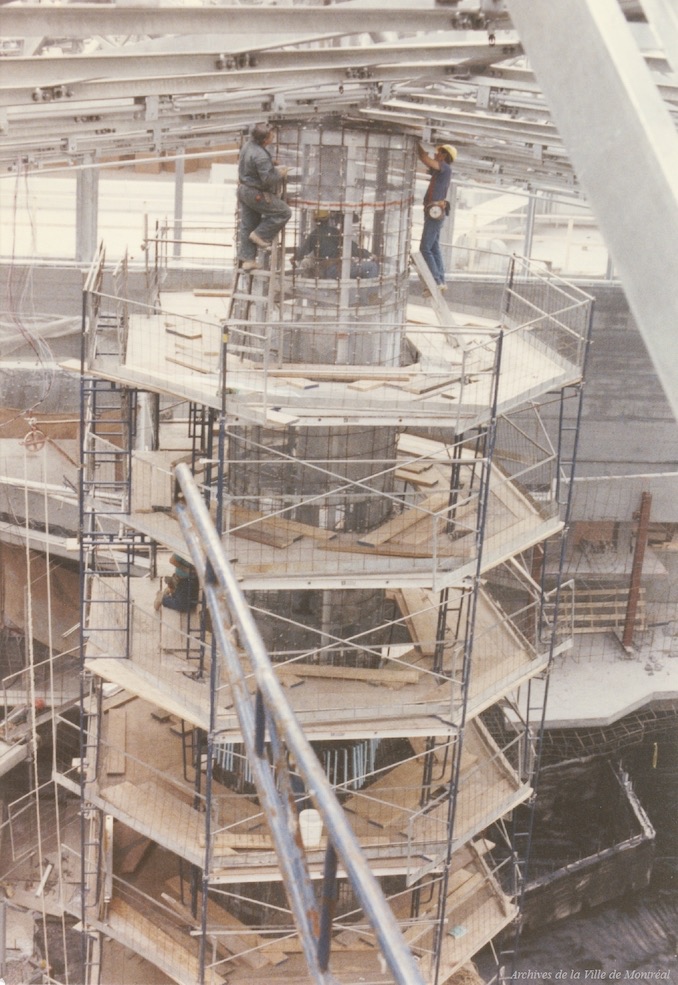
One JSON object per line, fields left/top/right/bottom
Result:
{"left": 88, "top": 680, "right": 530, "bottom": 881}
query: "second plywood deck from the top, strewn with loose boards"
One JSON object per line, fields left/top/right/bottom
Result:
{"left": 123, "top": 434, "right": 562, "bottom": 589}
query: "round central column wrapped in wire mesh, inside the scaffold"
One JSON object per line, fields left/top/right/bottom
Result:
{"left": 227, "top": 118, "right": 416, "bottom": 666}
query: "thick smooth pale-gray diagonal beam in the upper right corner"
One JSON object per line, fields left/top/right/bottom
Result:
{"left": 507, "top": 0, "right": 678, "bottom": 416}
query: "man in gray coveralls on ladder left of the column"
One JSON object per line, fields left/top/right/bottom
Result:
{"left": 238, "top": 123, "right": 292, "bottom": 270}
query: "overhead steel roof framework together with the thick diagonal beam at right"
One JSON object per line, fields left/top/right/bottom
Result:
{"left": 6, "top": 0, "right": 678, "bottom": 411}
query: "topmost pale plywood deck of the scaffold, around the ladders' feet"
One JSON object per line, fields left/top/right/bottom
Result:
{"left": 74, "top": 272, "right": 580, "bottom": 430}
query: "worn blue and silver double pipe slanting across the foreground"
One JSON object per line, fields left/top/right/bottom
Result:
{"left": 175, "top": 464, "right": 424, "bottom": 985}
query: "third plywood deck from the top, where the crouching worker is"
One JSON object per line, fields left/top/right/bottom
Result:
{"left": 86, "top": 552, "right": 546, "bottom": 741}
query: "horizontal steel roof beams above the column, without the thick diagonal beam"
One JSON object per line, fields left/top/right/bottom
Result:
{"left": 0, "top": 0, "right": 678, "bottom": 192}
